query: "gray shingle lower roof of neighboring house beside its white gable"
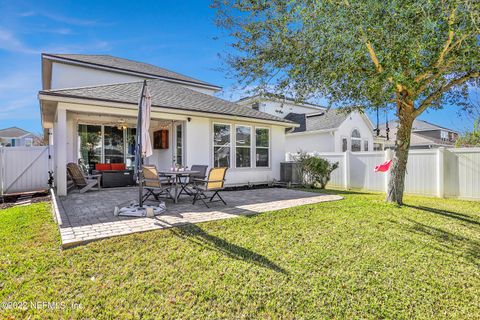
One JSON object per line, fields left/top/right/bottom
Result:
{"left": 285, "top": 109, "right": 349, "bottom": 132}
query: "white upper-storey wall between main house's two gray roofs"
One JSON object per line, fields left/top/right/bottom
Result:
{"left": 52, "top": 62, "right": 216, "bottom": 95}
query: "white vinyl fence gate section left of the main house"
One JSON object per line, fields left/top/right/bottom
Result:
{"left": 0, "top": 146, "right": 49, "bottom": 196}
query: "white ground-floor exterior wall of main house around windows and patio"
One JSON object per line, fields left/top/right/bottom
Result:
{"left": 53, "top": 103, "right": 285, "bottom": 195}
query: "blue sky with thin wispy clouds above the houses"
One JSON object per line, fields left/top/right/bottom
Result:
{"left": 0, "top": 0, "right": 472, "bottom": 133}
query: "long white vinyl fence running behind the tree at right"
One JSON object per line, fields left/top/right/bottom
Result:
{"left": 286, "top": 148, "right": 480, "bottom": 200}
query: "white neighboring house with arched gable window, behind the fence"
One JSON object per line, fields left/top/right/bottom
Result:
{"left": 237, "top": 94, "right": 376, "bottom": 153}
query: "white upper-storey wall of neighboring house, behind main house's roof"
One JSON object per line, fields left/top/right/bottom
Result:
{"left": 238, "top": 99, "right": 324, "bottom": 118}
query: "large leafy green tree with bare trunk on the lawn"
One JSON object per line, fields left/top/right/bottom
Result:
{"left": 213, "top": 0, "right": 480, "bottom": 204}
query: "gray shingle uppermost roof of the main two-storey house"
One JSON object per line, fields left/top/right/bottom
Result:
{"left": 44, "top": 53, "right": 220, "bottom": 88}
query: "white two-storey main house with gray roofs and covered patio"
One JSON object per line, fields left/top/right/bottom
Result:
{"left": 39, "top": 54, "right": 296, "bottom": 195}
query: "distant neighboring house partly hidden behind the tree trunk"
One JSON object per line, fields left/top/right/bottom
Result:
{"left": 379, "top": 120, "right": 458, "bottom": 149}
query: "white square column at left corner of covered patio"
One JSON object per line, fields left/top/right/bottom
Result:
{"left": 54, "top": 106, "right": 67, "bottom": 196}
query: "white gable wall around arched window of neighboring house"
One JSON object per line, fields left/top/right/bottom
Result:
{"left": 330, "top": 112, "right": 373, "bottom": 152}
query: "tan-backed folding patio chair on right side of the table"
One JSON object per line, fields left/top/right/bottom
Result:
{"left": 193, "top": 167, "right": 228, "bottom": 208}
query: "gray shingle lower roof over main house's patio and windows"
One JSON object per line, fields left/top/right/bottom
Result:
{"left": 40, "top": 79, "right": 293, "bottom": 124}
